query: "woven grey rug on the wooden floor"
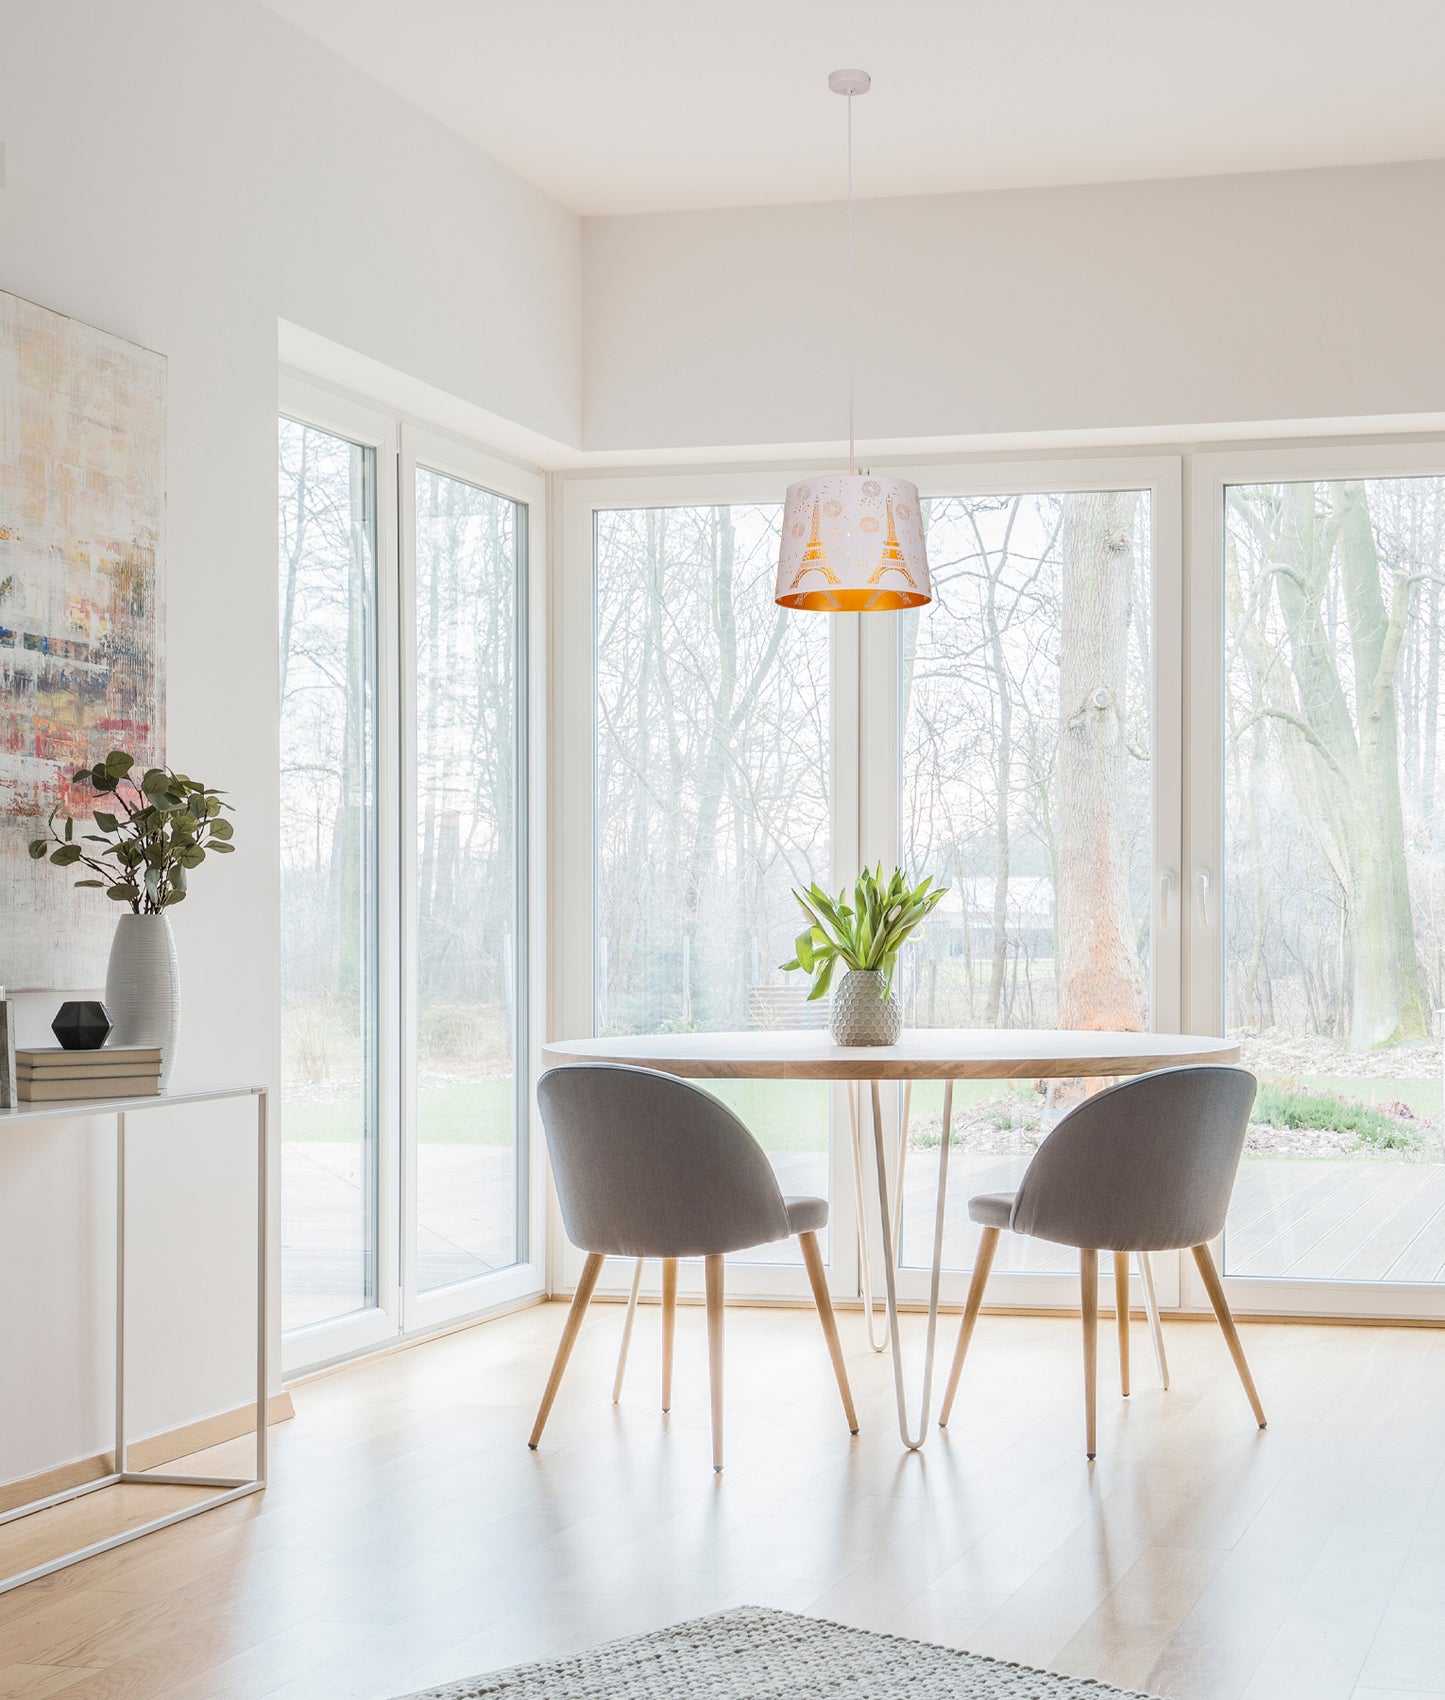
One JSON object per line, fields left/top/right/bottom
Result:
{"left": 397, "top": 1605, "right": 1149, "bottom": 1700}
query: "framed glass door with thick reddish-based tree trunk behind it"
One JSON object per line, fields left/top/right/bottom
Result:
{"left": 865, "top": 462, "right": 1180, "bottom": 1306}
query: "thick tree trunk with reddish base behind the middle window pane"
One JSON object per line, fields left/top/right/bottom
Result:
{"left": 1056, "top": 491, "right": 1148, "bottom": 1032}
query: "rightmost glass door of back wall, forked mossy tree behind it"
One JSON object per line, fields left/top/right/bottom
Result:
{"left": 1214, "top": 456, "right": 1445, "bottom": 1314}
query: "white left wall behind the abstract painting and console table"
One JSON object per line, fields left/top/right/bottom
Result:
{"left": 0, "top": 0, "right": 580, "bottom": 1479}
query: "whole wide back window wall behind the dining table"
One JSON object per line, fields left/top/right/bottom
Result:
{"left": 540, "top": 444, "right": 1445, "bottom": 1319}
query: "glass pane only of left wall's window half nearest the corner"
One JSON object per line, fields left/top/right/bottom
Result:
{"left": 415, "top": 466, "right": 527, "bottom": 1292}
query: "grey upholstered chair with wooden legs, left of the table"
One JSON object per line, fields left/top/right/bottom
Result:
{"left": 529, "top": 1063, "right": 859, "bottom": 1471}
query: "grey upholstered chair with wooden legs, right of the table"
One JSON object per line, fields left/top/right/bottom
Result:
{"left": 938, "top": 1066, "right": 1265, "bottom": 1457}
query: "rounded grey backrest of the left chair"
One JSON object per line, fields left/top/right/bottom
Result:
{"left": 537, "top": 1063, "right": 789, "bottom": 1258}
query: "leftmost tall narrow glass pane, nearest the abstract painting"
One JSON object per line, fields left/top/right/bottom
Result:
{"left": 281, "top": 418, "right": 377, "bottom": 1328}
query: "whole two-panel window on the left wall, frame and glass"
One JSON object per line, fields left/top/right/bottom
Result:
{"left": 279, "top": 384, "right": 542, "bottom": 1370}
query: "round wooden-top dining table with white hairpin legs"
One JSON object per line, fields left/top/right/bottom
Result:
{"left": 542, "top": 1027, "right": 1239, "bottom": 1452}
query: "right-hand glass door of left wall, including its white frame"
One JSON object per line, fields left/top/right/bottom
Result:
{"left": 401, "top": 427, "right": 541, "bottom": 1328}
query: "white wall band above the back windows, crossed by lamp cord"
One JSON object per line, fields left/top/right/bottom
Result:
{"left": 583, "top": 162, "right": 1445, "bottom": 452}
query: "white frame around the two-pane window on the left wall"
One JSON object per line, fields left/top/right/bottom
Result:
{"left": 277, "top": 369, "right": 551, "bottom": 1379}
